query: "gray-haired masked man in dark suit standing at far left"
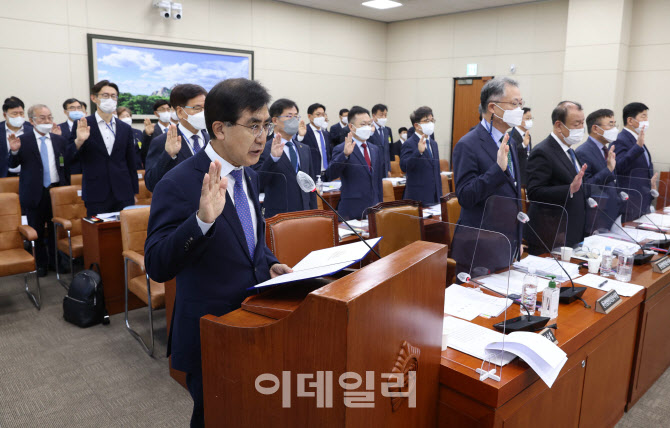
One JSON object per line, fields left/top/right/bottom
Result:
{"left": 8, "top": 104, "right": 67, "bottom": 276}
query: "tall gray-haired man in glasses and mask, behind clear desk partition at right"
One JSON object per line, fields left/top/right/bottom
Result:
{"left": 452, "top": 77, "right": 524, "bottom": 272}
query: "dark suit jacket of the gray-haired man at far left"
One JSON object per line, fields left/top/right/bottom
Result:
{"left": 9, "top": 129, "right": 67, "bottom": 209}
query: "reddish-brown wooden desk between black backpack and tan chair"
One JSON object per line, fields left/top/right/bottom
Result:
{"left": 81, "top": 220, "right": 146, "bottom": 315}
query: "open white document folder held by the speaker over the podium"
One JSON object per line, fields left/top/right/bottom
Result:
{"left": 249, "top": 237, "right": 382, "bottom": 290}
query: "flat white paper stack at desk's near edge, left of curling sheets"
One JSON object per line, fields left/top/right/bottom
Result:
{"left": 442, "top": 317, "right": 516, "bottom": 366}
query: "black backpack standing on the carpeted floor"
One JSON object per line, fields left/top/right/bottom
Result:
{"left": 63, "top": 263, "right": 109, "bottom": 327}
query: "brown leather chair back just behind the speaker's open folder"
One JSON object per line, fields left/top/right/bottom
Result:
{"left": 265, "top": 210, "right": 340, "bottom": 267}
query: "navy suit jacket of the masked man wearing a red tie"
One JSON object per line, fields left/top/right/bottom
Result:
{"left": 328, "top": 140, "right": 384, "bottom": 219}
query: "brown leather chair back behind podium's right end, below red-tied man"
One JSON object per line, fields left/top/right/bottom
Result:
{"left": 368, "top": 199, "right": 424, "bottom": 257}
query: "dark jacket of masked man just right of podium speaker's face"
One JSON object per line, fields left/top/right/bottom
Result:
{"left": 256, "top": 139, "right": 316, "bottom": 218}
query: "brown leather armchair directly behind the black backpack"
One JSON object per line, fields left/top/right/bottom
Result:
{"left": 49, "top": 185, "right": 86, "bottom": 289}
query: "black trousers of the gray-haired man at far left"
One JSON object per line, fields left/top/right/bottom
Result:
{"left": 25, "top": 187, "right": 56, "bottom": 269}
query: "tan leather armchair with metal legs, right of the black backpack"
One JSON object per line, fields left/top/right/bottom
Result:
{"left": 120, "top": 207, "right": 165, "bottom": 355}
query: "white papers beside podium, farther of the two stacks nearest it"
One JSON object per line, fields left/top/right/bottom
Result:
{"left": 444, "top": 284, "right": 512, "bottom": 321}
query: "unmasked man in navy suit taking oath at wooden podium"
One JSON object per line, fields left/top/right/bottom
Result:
{"left": 145, "top": 79, "right": 291, "bottom": 427}
